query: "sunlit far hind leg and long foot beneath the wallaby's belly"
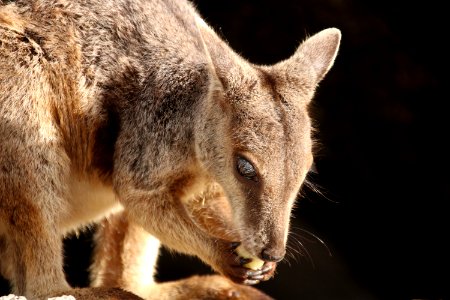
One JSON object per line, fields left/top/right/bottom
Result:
{"left": 91, "top": 212, "right": 272, "bottom": 300}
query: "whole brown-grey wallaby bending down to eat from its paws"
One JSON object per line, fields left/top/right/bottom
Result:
{"left": 0, "top": 0, "right": 341, "bottom": 299}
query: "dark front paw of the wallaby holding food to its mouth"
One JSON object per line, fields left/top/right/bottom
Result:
{"left": 216, "top": 242, "right": 276, "bottom": 285}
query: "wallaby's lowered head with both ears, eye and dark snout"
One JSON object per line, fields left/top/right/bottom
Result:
{"left": 196, "top": 28, "right": 341, "bottom": 261}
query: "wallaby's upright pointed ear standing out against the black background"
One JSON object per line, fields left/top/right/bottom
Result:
{"left": 281, "top": 28, "right": 341, "bottom": 86}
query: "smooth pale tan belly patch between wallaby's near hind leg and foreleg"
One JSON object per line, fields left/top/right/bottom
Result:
{"left": 61, "top": 179, "right": 123, "bottom": 232}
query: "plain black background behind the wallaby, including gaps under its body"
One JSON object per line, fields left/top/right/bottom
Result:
{"left": 1, "top": 0, "right": 450, "bottom": 300}
